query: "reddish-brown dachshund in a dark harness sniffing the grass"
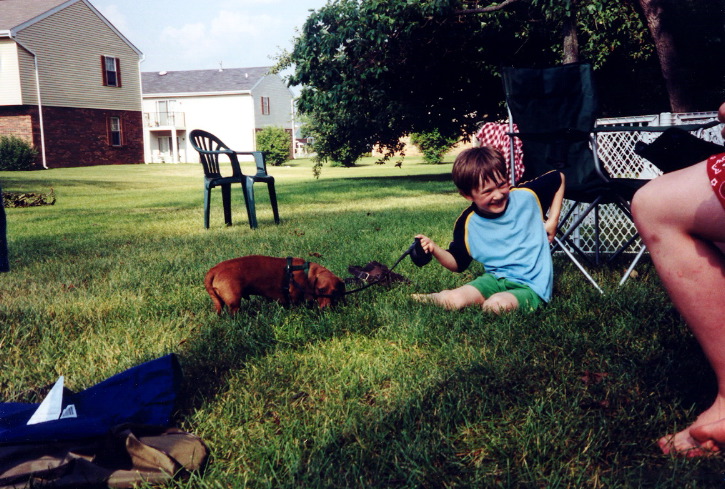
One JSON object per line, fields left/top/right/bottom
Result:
{"left": 204, "top": 255, "right": 345, "bottom": 315}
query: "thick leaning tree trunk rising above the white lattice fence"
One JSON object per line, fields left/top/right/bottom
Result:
{"left": 638, "top": 0, "right": 692, "bottom": 112}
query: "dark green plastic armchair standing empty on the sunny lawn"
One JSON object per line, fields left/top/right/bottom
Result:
{"left": 189, "top": 129, "right": 279, "bottom": 229}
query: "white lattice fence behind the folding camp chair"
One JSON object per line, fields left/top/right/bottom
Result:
{"left": 562, "top": 112, "right": 723, "bottom": 254}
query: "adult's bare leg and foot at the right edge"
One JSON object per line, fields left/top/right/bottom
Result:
{"left": 632, "top": 162, "right": 725, "bottom": 456}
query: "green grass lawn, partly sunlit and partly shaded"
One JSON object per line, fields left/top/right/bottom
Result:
{"left": 0, "top": 159, "right": 725, "bottom": 488}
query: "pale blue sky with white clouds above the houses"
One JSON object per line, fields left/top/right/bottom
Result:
{"left": 89, "top": 0, "right": 327, "bottom": 71}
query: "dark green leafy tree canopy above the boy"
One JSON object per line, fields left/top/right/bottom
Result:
{"left": 277, "top": 0, "right": 712, "bottom": 171}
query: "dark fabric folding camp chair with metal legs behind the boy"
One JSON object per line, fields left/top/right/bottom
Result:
{"left": 503, "top": 63, "right": 720, "bottom": 291}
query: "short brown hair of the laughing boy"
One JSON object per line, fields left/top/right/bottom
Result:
{"left": 452, "top": 146, "right": 508, "bottom": 196}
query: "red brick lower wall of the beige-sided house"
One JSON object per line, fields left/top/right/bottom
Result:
{"left": 0, "top": 106, "right": 144, "bottom": 168}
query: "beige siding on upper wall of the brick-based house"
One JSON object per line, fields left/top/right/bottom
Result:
{"left": 16, "top": 2, "right": 141, "bottom": 111}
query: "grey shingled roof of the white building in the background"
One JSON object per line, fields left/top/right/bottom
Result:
{"left": 143, "top": 67, "right": 271, "bottom": 95}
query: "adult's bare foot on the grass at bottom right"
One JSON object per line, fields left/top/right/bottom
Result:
{"left": 657, "top": 398, "right": 725, "bottom": 457}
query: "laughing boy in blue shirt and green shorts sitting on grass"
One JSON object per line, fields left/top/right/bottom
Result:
{"left": 413, "top": 147, "right": 564, "bottom": 314}
